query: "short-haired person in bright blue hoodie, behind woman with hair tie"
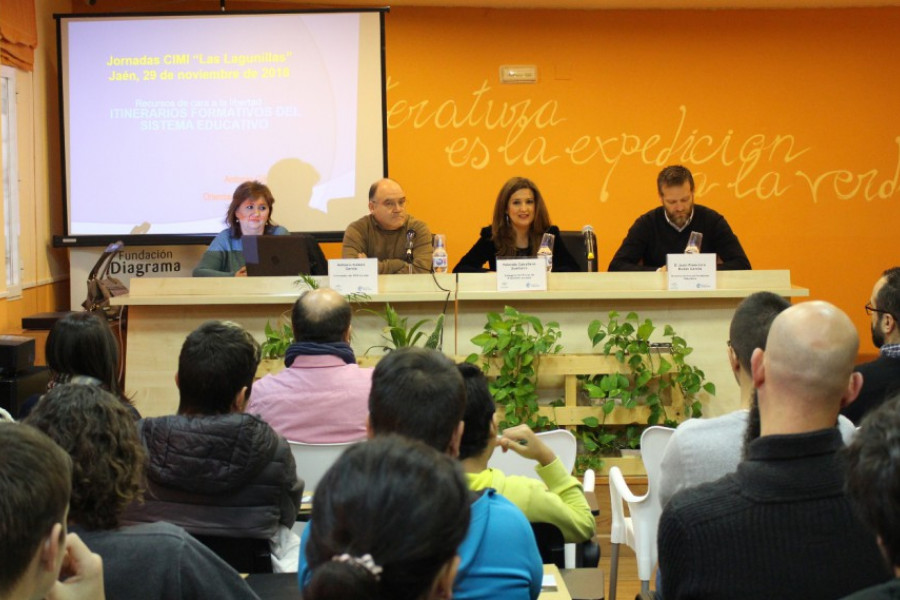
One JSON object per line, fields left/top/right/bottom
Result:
{"left": 299, "top": 348, "right": 543, "bottom": 600}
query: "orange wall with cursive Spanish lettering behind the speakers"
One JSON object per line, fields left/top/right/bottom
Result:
{"left": 56, "top": 0, "right": 900, "bottom": 353}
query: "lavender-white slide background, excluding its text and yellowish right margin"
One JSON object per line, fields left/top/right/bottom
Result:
{"left": 66, "top": 13, "right": 359, "bottom": 235}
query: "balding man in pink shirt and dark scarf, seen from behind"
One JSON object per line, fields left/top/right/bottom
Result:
{"left": 247, "top": 288, "right": 372, "bottom": 444}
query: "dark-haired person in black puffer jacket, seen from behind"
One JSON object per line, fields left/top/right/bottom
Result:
{"left": 122, "top": 321, "right": 302, "bottom": 572}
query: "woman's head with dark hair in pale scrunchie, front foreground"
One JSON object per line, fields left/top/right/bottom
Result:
{"left": 303, "top": 435, "right": 469, "bottom": 600}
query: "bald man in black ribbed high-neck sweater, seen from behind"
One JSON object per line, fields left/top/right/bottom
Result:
{"left": 658, "top": 302, "right": 890, "bottom": 600}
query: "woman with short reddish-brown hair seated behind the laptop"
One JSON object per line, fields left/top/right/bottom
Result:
{"left": 194, "top": 181, "right": 288, "bottom": 277}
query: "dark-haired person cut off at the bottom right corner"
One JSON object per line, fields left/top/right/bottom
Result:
{"left": 845, "top": 396, "right": 900, "bottom": 600}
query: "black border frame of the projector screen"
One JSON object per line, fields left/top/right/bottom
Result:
{"left": 52, "top": 6, "right": 390, "bottom": 248}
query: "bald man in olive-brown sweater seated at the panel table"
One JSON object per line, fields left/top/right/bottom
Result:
{"left": 341, "top": 178, "right": 432, "bottom": 275}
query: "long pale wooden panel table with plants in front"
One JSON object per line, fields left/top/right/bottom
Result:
{"left": 112, "top": 271, "right": 809, "bottom": 416}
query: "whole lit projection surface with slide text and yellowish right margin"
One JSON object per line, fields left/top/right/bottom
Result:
{"left": 59, "top": 11, "right": 384, "bottom": 236}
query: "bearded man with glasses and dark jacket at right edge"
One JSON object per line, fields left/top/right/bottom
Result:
{"left": 841, "top": 267, "right": 900, "bottom": 425}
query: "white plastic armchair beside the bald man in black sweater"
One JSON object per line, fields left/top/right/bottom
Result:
{"left": 609, "top": 426, "right": 675, "bottom": 600}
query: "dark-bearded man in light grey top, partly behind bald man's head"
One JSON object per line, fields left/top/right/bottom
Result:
{"left": 659, "top": 292, "right": 856, "bottom": 506}
